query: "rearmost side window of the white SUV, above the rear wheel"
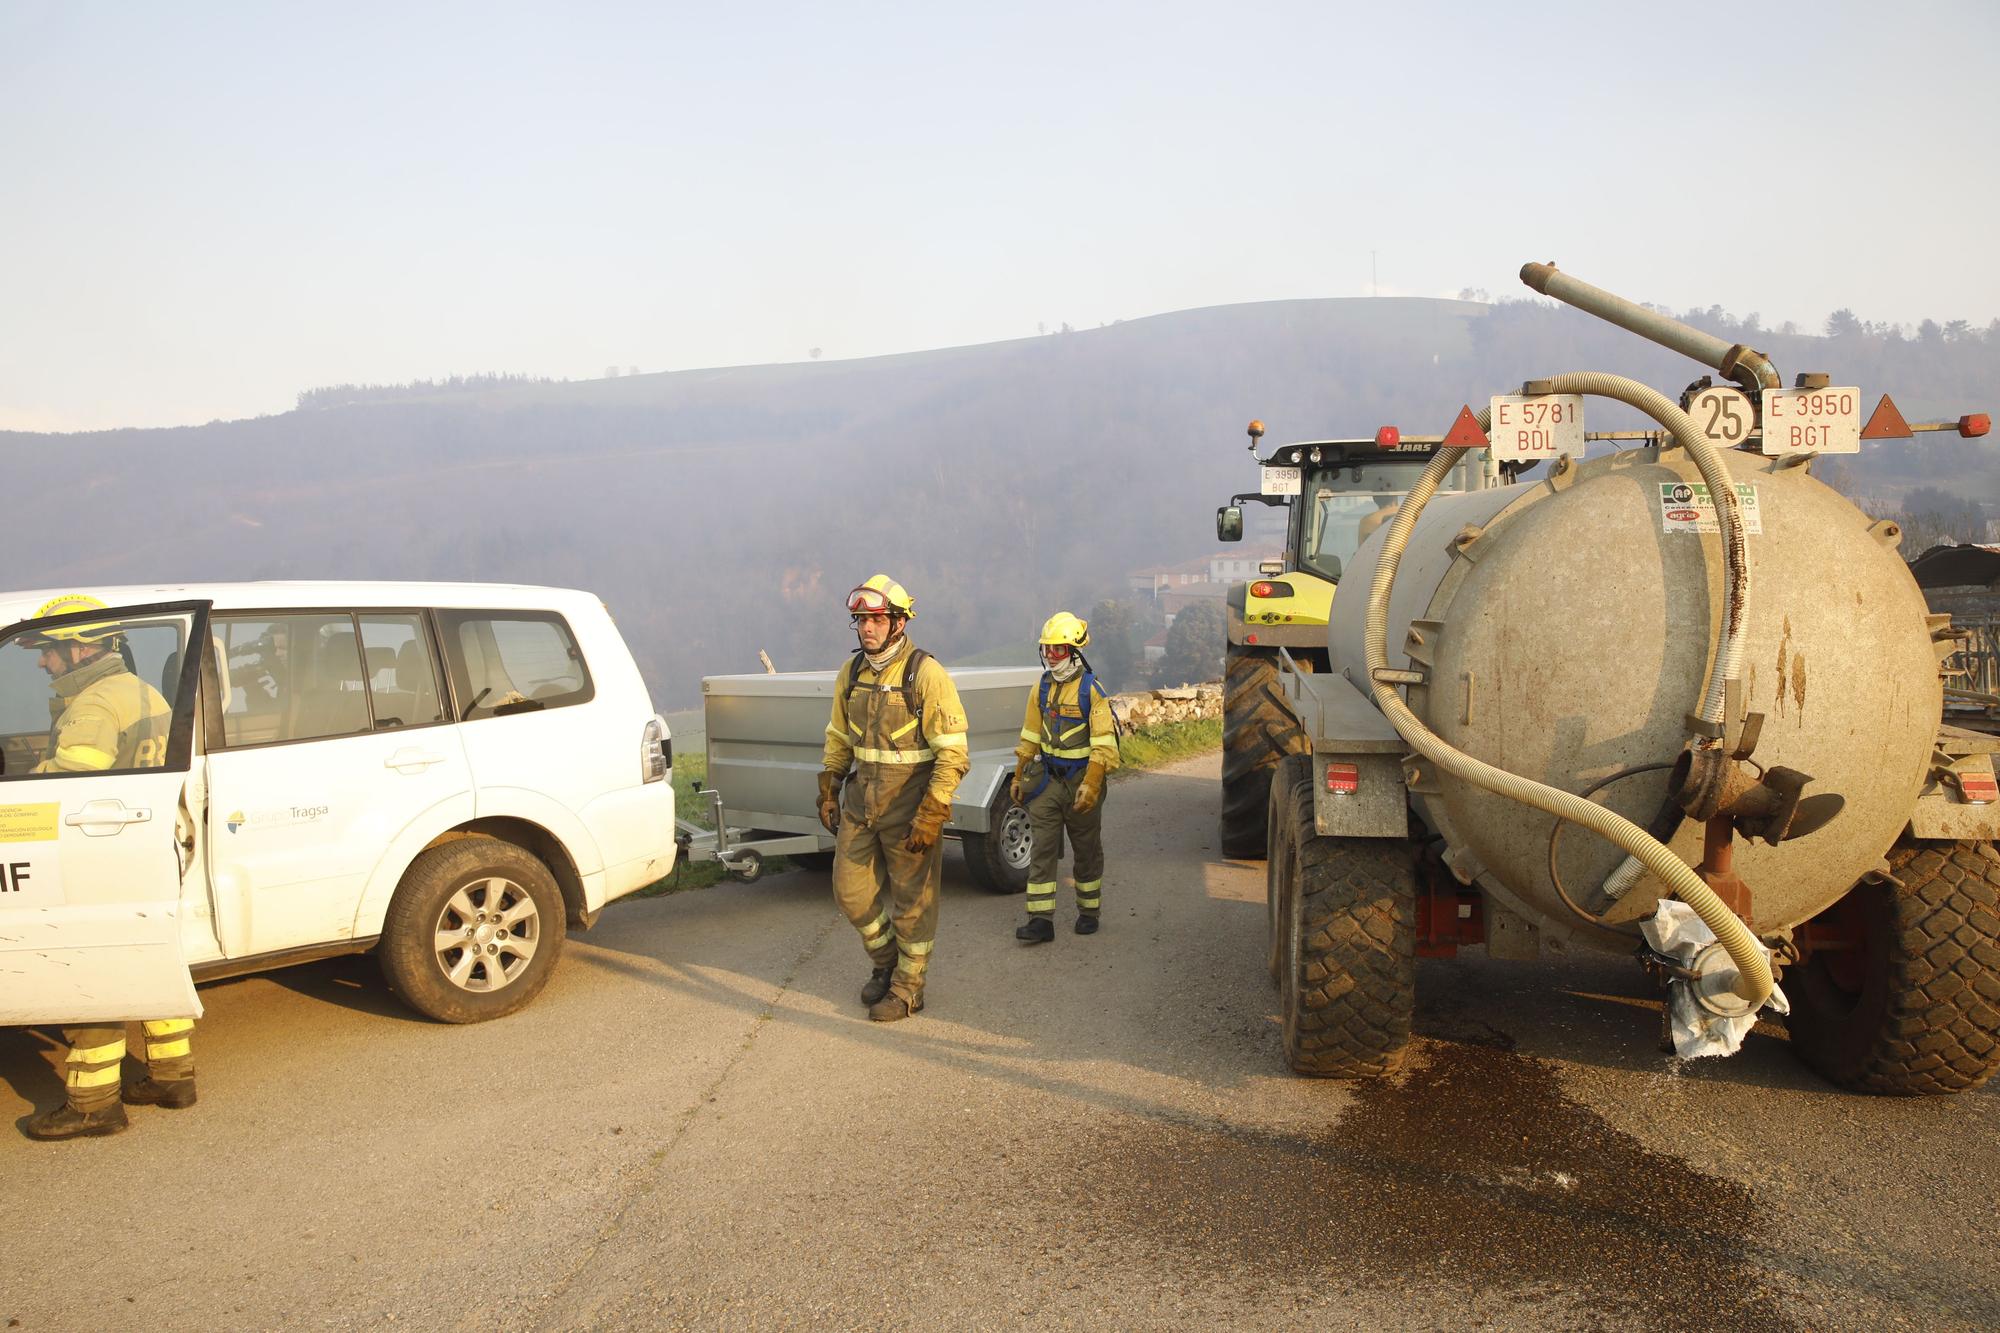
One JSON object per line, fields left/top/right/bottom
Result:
{"left": 438, "top": 610, "right": 594, "bottom": 721}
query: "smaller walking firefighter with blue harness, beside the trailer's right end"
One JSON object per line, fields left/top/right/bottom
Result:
{"left": 1012, "top": 610, "right": 1118, "bottom": 945}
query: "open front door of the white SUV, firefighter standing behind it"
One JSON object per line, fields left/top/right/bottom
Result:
{"left": 0, "top": 602, "right": 210, "bottom": 1025}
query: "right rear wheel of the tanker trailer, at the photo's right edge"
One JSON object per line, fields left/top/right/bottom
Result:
{"left": 1786, "top": 839, "right": 2000, "bottom": 1097}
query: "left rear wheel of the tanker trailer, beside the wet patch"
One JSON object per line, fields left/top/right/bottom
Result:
{"left": 1274, "top": 781, "right": 1416, "bottom": 1079}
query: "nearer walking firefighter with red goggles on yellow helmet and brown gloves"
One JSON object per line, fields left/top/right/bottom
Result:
{"left": 820, "top": 574, "right": 970, "bottom": 1023}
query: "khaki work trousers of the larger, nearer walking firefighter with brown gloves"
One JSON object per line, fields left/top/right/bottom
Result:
{"left": 834, "top": 765, "right": 944, "bottom": 996}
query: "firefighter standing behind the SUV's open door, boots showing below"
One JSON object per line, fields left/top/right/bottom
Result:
{"left": 26, "top": 594, "right": 194, "bottom": 1139}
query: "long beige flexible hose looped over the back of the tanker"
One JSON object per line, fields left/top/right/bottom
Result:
{"left": 1364, "top": 372, "right": 1774, "bottom": 1009}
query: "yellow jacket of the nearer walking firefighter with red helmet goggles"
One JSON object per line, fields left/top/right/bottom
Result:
{"left": 820, "top": 636, "right": 972, "bottom": 823}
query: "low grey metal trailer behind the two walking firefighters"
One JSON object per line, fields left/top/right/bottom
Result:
{"left": 678, "top": 667, "right": 1040, "bottom": 893}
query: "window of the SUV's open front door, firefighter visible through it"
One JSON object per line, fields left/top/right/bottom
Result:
{"left": 0, "top": 610, "right": 192, "bottom": 779}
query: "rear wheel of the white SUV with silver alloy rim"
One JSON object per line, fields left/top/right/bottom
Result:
{"left": 380, "top": 837, "right": 566, "bottom": 1023}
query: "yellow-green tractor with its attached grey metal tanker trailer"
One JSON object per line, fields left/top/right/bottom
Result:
{"left": 1216, "top": 264, "right": 2000, "bottom": 1095}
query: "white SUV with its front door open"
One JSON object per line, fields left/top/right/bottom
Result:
{"left": 0, "top": 582, "right": 674, "bottom": 1025}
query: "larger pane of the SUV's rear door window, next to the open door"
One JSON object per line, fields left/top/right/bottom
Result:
{"left": 214, "top": 612, "right": 368, "bottom": 747}
